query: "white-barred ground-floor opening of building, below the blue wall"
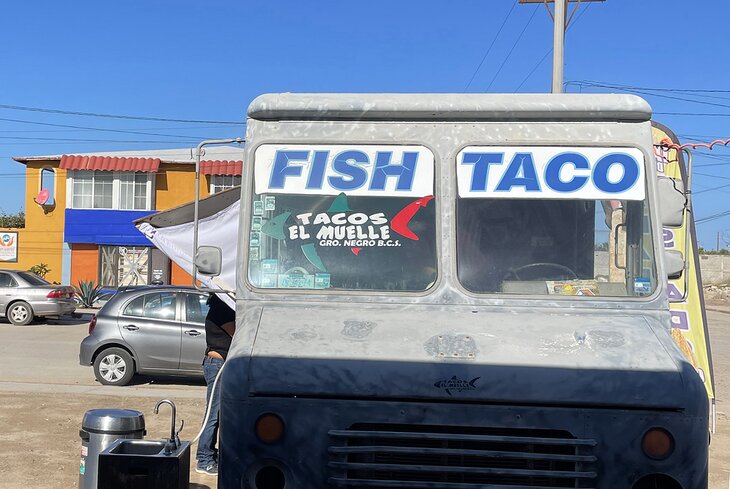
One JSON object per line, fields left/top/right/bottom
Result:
{"left": 99, "top": 246, "right": 150, "bottom": 288}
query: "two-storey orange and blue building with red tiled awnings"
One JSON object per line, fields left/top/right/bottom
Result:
{"left": 0, "top": 146, "right": 243, "bottom": 289}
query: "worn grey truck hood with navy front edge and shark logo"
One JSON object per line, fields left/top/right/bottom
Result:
{"left": 246, "top": 306, "right": 686, "bottom": 409}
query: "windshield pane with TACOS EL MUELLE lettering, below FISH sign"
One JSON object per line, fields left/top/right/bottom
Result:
{"left": 249, "top": 193, "right": 437, "bottom": 292}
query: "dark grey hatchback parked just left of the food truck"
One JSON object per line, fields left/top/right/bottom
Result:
{"left": 79, "top": 286, "right": 208, "bottom": 385}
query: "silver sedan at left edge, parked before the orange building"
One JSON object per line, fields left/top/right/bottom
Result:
{"left": 0, "top": 270, "right": 76, "bottom": 326}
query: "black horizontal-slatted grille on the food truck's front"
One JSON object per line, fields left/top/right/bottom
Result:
{"left": 328, "top": 424, "right": 596, "bottom": 489}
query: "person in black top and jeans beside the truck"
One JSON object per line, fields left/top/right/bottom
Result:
{"left": 195, "top": 294, "right": 236, "bottom": 475}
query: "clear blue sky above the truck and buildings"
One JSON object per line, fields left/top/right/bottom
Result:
{"left": 0, "top": 0, "right": 730, "bottom": 248}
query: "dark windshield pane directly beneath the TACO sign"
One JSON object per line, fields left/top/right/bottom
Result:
{"left": 456, "top": 198, "right": 656, "bottom": 296}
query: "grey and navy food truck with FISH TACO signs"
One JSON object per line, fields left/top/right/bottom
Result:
{"left": 139, "top": 94, "right": 709, "bottom": 489}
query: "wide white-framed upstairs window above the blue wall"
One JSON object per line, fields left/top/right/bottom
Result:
{"left": 69, "top": 170, "right": 152, "bottom": 210}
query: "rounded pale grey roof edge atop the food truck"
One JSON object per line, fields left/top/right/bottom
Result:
{"left": 248, "top": 93, "right": 652, "bottom": 122}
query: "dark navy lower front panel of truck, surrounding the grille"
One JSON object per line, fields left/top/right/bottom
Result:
{"left": 218, "top": 391, "right": 708, "bottom": 489}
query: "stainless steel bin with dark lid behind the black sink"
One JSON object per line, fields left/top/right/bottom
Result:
{"left": 79, "top": 409, "right": 146, "bottom": 489}
